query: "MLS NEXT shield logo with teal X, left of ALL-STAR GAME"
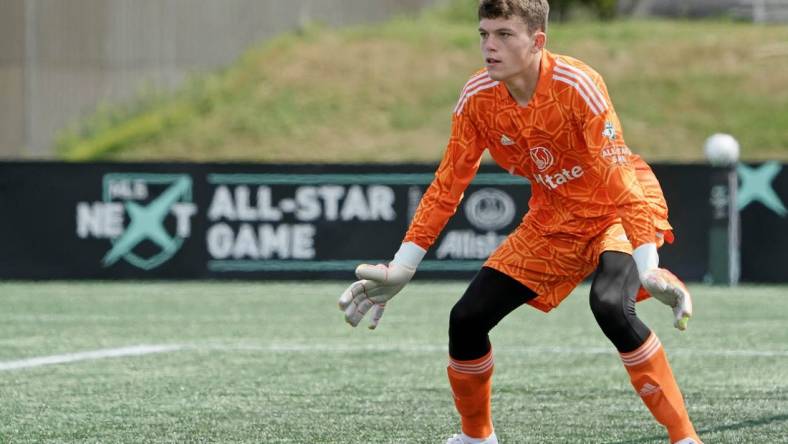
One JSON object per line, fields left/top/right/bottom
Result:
{"left": 77, "top": 173, "right": 197, "bottom": 270}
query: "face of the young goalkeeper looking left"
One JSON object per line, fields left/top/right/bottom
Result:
{"left": 479, "top": 17, "right": 545, "bottom": 81}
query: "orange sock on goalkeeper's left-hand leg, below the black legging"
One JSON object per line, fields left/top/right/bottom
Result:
{"left": 446, "top": 349, "right": 493, "bottom": 438}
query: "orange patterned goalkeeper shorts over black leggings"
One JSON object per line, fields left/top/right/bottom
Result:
{"left": 484, "top": 222, "right": 672, "bottom": 312}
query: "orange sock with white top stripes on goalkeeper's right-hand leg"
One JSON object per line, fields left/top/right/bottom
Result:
{"left": 621, "top": 332, "right": 700, "bottom": 442}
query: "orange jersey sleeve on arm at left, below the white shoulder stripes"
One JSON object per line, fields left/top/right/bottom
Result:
{"left": 403, "top": 114, "right": 484, "bottom": 250}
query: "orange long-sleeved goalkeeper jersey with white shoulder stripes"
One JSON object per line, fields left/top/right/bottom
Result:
{"left": 405, "top": 50, "right": 670, "bottom": 249}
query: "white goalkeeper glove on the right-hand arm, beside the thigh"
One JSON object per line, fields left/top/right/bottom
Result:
{"left": 632, "top": 243, "right": 692, "bottom": 330}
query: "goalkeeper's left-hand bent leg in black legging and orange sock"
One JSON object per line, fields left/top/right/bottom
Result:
{"left": 447, "top": 267, "right": 535, "bottom": 444}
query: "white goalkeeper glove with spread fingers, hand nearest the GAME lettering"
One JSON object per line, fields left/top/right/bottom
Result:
{"left": 339, "top": 242, "right": 426, "bottom": 329}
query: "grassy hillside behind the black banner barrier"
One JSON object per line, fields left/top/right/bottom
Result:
{"left": 59, "top": 2, "right": 788, "bottom": 162}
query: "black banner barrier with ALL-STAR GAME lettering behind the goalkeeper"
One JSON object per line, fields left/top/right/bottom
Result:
{"left": 0, "top": 162, "right": 788, "bottom": 282}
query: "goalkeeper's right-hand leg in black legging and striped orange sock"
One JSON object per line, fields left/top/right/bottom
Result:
{"left": 590, "top": 251, "right": 700, "bottom": 444}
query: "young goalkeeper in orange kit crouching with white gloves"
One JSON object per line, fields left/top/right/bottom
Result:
{"left": 339, "top": 0, "right": 700, "bottom": 444}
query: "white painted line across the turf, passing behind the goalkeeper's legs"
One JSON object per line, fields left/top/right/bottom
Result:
{"left": 0, "top": 343, "right": 788, "bottom": 371}
